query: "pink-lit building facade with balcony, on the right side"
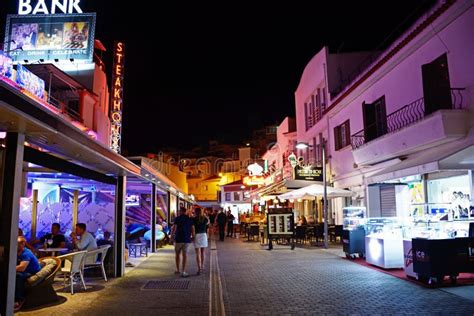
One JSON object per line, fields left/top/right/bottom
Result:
{"left": 295, "top": 1, "right": 474, "bottom": 224}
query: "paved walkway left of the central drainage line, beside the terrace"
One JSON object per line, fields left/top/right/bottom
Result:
{"left": 19, "top": 246, "right": 209, "bottom": 316}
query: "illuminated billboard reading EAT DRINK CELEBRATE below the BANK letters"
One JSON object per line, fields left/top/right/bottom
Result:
{"left": 5, "top": 13, "right": 96, "bottom": 64}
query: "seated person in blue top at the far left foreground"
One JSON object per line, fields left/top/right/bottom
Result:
{"left": 14, "top": 236, "right": 41, "bottom": 311}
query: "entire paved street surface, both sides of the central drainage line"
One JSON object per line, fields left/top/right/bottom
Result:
{"left": 20, "top": 239, "right": 474, "bottom": 316}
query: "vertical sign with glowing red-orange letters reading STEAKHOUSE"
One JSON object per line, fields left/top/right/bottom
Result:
{"left": 110, "top": 42, "right": 125, "bottom": 153}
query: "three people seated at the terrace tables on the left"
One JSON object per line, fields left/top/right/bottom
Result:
{"left": 14, "top": 223, "right": 97, "bottom": 311}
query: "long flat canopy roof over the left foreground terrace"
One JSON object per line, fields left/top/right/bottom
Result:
{"left": 0, "top": 81, "right": 140, "bottom": 176}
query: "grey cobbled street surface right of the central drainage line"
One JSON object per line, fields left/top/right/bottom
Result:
{"left": 217, "top": 239, "right": 474, "bottom": 315}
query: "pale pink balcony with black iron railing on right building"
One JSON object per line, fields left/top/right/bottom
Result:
{"left": 351, "top": 88, "right": 469, "bottom": 165}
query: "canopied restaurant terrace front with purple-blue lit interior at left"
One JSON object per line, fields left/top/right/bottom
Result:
{"left": 0, "top": 67, "right": 140, "bottom": 310}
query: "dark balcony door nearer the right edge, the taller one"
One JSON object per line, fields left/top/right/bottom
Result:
{"left": 421, "top": 54, "right": 452, "bottom": 115}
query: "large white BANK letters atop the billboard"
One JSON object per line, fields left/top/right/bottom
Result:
{"left": 18, "top": 0, "right": 83, "bottom": 15}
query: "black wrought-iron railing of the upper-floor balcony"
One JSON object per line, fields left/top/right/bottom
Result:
{"left": 351, "top": 88, "right": 465, "bottom": 149}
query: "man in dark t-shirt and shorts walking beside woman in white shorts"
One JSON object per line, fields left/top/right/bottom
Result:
{"left": 171, "top": 207, "right": 194, "bottom": 278}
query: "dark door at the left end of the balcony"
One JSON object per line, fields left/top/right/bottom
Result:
{"left": 362, "top": 96, "right": 387, "bottom": 142}
